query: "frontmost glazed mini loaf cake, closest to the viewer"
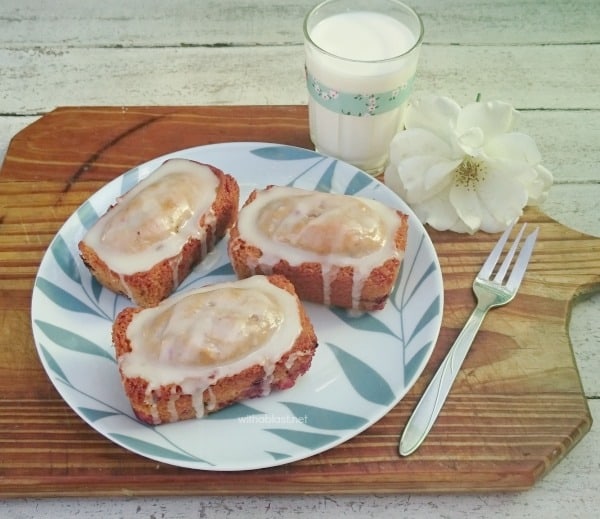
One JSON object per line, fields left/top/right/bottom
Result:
{"left": 112, "top": 276, "right": 317, "bottom": 424}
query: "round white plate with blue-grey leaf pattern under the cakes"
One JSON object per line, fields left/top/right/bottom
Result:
{"left": 31, "top": 143, "right": 443, "bottom": 470}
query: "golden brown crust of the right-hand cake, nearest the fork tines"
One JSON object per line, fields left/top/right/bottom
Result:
{"left": 228, "top": 186, "right": 408, "bottom": 311}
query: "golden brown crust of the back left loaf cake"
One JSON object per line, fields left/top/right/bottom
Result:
{"left": 79, "top": 164, "right": 239, "bottom": 307}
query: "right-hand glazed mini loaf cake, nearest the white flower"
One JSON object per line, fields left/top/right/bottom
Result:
{"left": 228, "top": 186, "right": 408, "bottom": 311}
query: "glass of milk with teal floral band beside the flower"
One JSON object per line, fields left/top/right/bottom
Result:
{"left": 304, "top": 0, "right": 423, "bottom": 175}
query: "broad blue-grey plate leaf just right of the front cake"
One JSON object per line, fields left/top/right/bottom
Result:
{"left": 326, "top": 343, "right": 394, "bottom": 405}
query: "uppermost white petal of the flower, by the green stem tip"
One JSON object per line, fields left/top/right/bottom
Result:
{"left": 456, "top": 101, "right": 518, "bottom": 139}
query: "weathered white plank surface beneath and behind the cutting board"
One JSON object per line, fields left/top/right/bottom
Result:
{"left": 0, "top": 0, "right": 600, "bottom": 519}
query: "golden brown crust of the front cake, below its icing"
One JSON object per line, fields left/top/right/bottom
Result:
{"left": 112, "top": 276, "right": 317, "bottom": 424}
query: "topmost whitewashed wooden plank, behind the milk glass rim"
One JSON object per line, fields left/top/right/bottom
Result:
{"left": 0, "top": 0, "right": 598, "bottom": 46}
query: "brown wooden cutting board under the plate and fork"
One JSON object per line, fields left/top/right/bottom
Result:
{"left": 0, "top": 106, "right": 600, "bottom": 496}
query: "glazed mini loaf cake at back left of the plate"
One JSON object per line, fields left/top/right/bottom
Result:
{"left": 79, "top": 159, "right": 239, "bottom": 307}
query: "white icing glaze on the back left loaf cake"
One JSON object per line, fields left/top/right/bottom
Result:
{"left": 83, "top": 159, "right": 219, "bottom": 276}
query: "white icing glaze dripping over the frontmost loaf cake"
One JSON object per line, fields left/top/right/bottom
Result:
{"left": 119, "top": 276, "right": 302, "bottom": 423}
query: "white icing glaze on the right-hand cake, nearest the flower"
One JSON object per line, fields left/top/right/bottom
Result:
{"left": 237, "top": 186, "right": 404, "bottom": 306}
